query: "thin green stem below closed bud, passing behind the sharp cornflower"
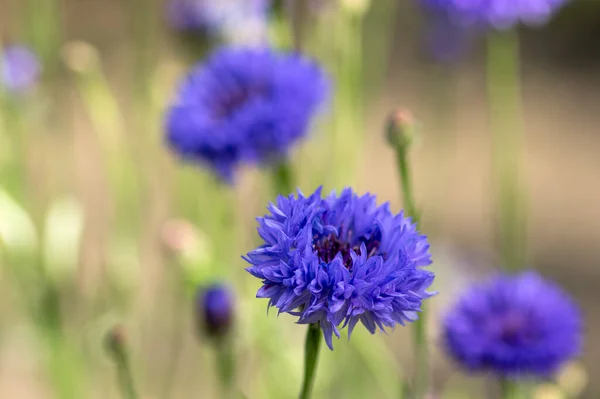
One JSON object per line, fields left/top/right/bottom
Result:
{"left": 394, "top": 132, "right": 429, "bottom": 399}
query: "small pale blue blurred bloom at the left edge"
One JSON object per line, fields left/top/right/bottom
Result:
{"left": 0, "top": 45, "right": 40, "bottom": 93}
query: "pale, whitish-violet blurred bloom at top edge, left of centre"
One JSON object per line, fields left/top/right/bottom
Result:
{"left": 167, "top": 0, "right": 270, "bottom": 44}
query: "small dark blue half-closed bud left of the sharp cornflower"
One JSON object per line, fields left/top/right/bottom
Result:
{"left": 196, "top": 283, "right": 235, "bottom": 338}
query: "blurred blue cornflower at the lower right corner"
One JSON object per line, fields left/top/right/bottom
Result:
{"left": 444, "top": 271, "right": 582, "bottom": 378}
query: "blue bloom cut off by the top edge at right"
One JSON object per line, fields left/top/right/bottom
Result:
{"left": 421, "top": 0, "right": 568, "bottom": 29}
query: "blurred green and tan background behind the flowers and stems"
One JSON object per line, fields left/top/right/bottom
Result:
{"left": 0, "top": 0, "right": 600, "bottom": 399}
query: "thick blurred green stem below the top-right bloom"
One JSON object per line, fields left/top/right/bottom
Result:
{"left": 487, "top": 30, "right": 526, "bottom": 270}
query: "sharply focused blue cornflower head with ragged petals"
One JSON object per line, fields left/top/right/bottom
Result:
{"left": 245, "top": 188, "right": 434, "bottom": 349}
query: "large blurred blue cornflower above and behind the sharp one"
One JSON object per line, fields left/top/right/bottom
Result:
{"left": 166, "top": 48, "right": 327, "bottom": 181}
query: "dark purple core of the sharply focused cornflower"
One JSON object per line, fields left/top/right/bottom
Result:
{"left": 313, "top": 234, "right": 380, "bottom": 270}
